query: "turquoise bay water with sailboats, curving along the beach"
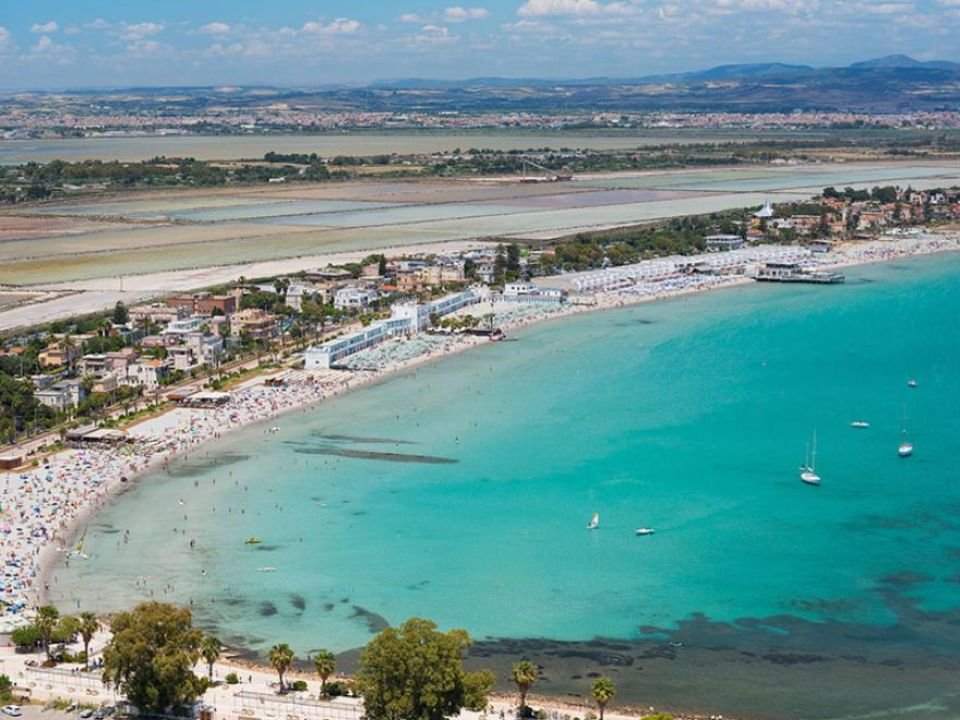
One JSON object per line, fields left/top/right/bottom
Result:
{"left": 51, "top": 255, "right": 960, "bottom": 718}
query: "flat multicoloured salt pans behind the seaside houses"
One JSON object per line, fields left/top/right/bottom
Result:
{"left": 0, "top": 161, "right": 960, "bottom": 328}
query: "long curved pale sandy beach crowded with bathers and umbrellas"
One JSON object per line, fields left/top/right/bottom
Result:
{"left": 0, "top": 233, "right": 960, "bottom": 630}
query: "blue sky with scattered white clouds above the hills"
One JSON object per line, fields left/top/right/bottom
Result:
{"left": 0, "top": 0, "right": 960, "bottom": 89}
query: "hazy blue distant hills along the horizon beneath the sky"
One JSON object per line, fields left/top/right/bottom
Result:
{"left": 41, "top": 55, "right": 960, "bottom": 113}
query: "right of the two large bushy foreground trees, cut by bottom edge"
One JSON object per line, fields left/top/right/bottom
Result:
{"left": 357, "top": 618, "right": 493, "bottom": 720}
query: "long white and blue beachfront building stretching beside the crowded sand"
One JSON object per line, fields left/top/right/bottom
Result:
{"left": 304, "top": 289, "right": 482, "bottom": 370}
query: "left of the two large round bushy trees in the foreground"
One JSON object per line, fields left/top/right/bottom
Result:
{"left": 103, "top": 602, "right": 207, "bottom": 713}
